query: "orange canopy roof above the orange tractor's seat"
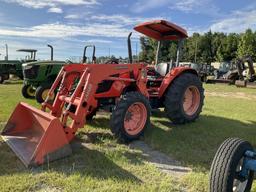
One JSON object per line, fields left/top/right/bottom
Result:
{"left": 134, "top": 20, "right": 188, "bottom": 41}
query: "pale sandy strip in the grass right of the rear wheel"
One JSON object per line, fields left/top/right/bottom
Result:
{"left": 205, "top": 91, "right": 256, "bottom": 100}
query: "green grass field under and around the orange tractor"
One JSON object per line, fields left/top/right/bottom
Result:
{"left": 0, "top": 82, "right": 256, "bottom": 192}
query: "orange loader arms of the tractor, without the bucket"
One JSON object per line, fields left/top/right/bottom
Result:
{"left": 42, "top": 64, "right": 148, "bottom": 141}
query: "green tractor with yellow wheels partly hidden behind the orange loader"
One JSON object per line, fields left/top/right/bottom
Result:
{"left": 22, "top": 45, "right": 96, "bottom": 103}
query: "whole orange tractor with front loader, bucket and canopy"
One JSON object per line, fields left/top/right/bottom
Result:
{"left": 1, "top": 20, "right": 204, "bottom": 166}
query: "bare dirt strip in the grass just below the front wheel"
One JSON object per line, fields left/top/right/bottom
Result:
{"left": 130, "top": 141, "right": 192, "bottom": 177}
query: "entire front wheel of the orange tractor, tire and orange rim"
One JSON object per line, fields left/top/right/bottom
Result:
{"left": 110, "top": 91, "right": 151, "bottom": 143}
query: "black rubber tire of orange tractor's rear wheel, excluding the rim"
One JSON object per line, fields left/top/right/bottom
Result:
{"left": 164, "top": 73, "right": 204, "bottom": 124}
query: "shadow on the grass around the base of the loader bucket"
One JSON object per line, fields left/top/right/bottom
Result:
{"left": 0, "top": 133, "right": 142, "bottom": 183}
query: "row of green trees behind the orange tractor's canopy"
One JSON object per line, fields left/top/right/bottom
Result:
{"left": 139, "top": 29, "right": 256, "bottom": 64}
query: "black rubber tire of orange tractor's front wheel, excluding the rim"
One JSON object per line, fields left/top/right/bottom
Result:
{"left": 110, "top": 92, "right": 151, "bottom": 143}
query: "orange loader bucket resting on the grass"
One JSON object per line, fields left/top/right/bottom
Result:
{"left": 1, "top": 103, "right": 72, "bottom": 167}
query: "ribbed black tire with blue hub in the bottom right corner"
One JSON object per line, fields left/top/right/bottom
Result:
{"left": 209, "top": 138, "right": 254, "bottom": 192}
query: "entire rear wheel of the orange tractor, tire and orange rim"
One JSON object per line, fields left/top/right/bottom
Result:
{"left": 164, "top": 73, "right": 204, "bottom": 124}
